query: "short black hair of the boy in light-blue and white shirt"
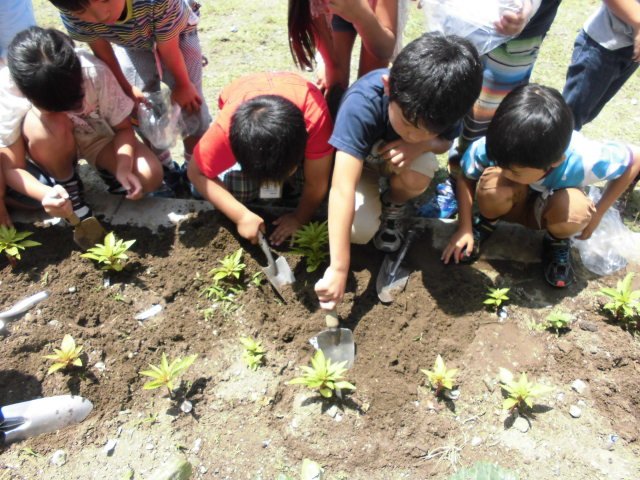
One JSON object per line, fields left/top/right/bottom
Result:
{"left": 486, "top": 83, "right": 573, "bottom": 170}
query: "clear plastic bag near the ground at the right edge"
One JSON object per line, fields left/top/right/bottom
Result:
{"left": 573, "top": 187, "right": 640, "bottom": 275}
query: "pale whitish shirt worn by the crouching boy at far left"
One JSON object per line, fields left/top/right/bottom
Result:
{"left": 0, "top": 50, "right": 134, "bottom": 147}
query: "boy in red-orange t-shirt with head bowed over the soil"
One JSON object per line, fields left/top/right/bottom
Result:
{"left": 187, "top": 73, "right": 333, "bottom": 245}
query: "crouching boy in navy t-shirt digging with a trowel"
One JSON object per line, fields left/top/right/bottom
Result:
{"left": 316, "top": 34, "right": 482, "bottom": 309}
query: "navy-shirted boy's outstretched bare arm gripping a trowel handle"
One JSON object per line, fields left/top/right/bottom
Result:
{"left": 315, "top": 151, "right": 363, "bottom": 309}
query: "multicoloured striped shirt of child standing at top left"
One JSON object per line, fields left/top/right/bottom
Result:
{"left": 60, "top": 0, "right": 198, "bottom": 50}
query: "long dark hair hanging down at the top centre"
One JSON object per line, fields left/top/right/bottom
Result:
{"left": 287, "top": 0, "right": 316, "bottom": 70}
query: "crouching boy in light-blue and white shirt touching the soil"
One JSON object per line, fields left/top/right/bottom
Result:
{"left": 442, "top": 84, "right": 640, "bottom": 287}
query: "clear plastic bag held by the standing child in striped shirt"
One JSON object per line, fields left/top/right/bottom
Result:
{"left": 138, "top": 90, "right": 185, "bottom": 150}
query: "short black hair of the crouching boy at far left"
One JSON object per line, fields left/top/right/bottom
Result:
{"left": 7, "top": 27, "right": 84, "bottom": 112}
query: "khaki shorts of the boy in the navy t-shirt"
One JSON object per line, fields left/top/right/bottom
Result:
{"left": 351, "top": 142, "right": 439, "bottom": 244}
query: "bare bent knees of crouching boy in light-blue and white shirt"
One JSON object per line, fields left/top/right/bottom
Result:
{"left": 476, "top": 167, "right": 596, "bottom": 230}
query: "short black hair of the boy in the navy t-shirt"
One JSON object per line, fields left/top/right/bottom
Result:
{"left": 389, "top": 33, "right": 482, "bottom": 133}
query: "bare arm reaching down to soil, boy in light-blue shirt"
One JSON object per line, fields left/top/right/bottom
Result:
{"left": 440, "top": 174, "right": 476, "bottom": 263}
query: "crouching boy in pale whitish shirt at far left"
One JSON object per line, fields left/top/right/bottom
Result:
{"left": 0, "top": 27, "right": 162, "bottom": 219}
